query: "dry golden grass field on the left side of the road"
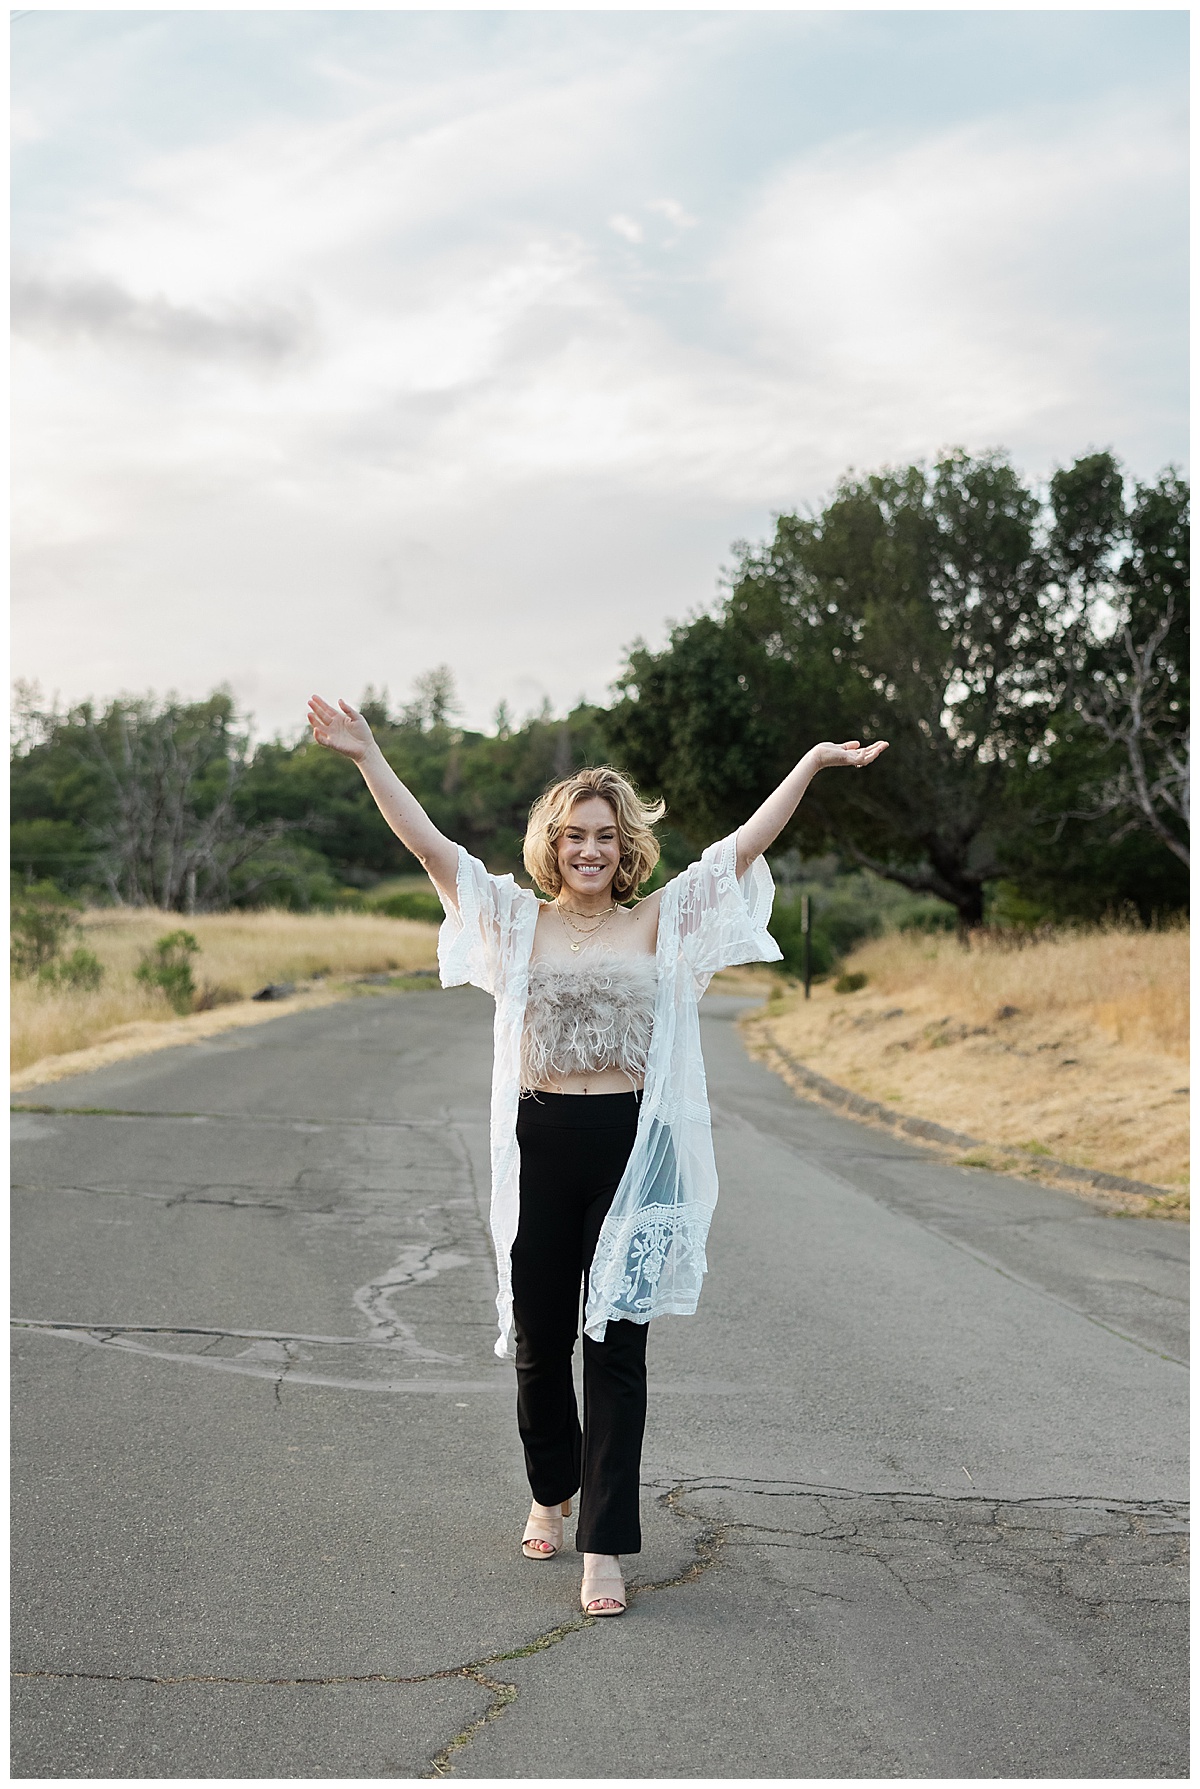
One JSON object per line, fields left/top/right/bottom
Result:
{"left": 11, "top": 907, "right": 436, "bottom": 1084}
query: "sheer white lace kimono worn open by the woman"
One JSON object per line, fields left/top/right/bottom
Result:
{"left": 438, "top": 834, "right": 782, "bottom": 1354}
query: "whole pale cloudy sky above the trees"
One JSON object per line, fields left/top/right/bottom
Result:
{"left": 13, "top": 11, "right": 1187, "bottom": 733}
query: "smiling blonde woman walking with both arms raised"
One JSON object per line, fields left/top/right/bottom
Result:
{"left": 309, "top": 696, "right": 887, "bottom": 1615}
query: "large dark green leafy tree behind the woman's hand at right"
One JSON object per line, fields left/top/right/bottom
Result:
{"left": 610, "top": 453, "right": 1173, "bottom": 930}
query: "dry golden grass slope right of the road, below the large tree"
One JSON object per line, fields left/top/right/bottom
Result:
{"left": 749, "top": 928, "right": 1189, "bottom": 1191}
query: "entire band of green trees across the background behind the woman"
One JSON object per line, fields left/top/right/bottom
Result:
{"left": 13, "top": 453, "right": 1189, "bottom": 927}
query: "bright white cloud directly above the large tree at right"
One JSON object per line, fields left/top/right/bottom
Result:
{"left": 717, "top": 99, "right": 1186, "bottom": 463}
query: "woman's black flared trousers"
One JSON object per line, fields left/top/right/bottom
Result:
{"left": 513, "top": 1093, "right": 647, "bottom": 1553}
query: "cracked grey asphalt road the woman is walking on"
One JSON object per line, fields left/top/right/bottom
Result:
{"left": 13, "top": 991, "right": 1187, "bottom": 1778}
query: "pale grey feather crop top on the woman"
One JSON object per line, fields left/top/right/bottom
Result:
{"left": 520, "top": 950, "right": 658, "bottom": 1088}
